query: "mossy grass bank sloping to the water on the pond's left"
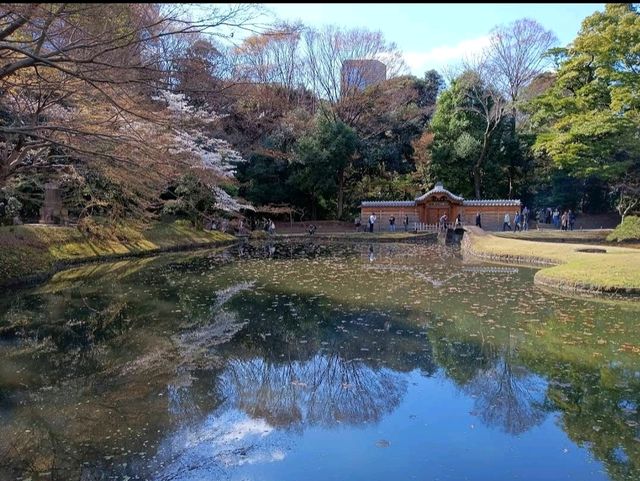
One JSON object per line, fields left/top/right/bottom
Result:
{"left": 0, "top": 221, "right": 234, "bottom": 285}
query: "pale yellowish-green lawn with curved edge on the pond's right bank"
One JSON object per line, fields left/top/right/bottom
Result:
{"left": 465, "top": 228, "right": 640, "bottom": 294}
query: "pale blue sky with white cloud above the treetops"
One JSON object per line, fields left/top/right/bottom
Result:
{"left": 252, "top": 3, "right": 604, "bottom": 77}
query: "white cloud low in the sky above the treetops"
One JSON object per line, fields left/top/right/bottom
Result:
{"left": 404, "top": 35, "right": 490, "bottom": 77}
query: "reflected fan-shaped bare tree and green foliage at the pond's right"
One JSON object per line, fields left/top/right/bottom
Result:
{"left": 430, "top": 320, "right": 640, "bottom": 481}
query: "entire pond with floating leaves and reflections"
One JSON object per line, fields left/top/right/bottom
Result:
{"left": 0, "top": 240, "right": 640, "bottom": 481}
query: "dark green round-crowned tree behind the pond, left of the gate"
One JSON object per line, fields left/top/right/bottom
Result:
{"left": 290, "top": 115, "right": 358, "bottom": 219}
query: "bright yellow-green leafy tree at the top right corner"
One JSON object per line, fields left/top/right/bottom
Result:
{"left": 528, "top": 4, "right": 640, "bottom": 186}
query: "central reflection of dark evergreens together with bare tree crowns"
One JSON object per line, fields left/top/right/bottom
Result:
{"left": 210, "top": 290, "right": 435, "bottom": 428}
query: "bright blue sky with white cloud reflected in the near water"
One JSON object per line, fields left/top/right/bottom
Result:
{"left": 154, "top": 371, "right": 607, "bottom": 481}
